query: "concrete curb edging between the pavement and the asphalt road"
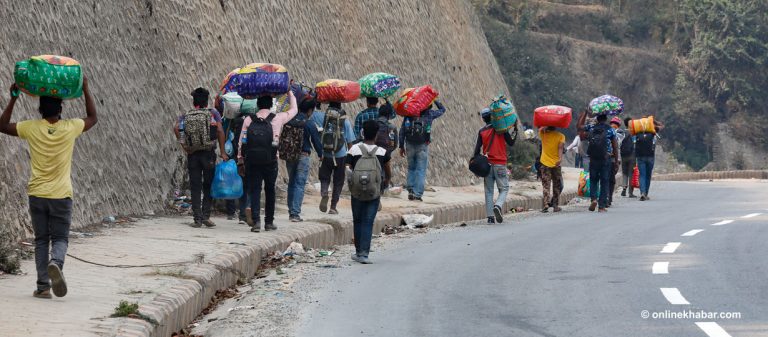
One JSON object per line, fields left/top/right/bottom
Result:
{"left": 109, "top": 191, "right": 576, "bottom": 337}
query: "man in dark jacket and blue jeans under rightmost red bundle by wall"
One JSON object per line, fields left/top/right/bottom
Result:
{"left": 399, "top": 101, "right": 445, "bottom": 201}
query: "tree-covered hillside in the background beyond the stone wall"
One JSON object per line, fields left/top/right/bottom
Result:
{"left": 474, "top": 0, "right": 768, "bottom": 169}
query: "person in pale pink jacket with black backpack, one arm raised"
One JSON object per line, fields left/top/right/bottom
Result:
{"left": 237, "top": 91, "right": 299, "bottom": 232}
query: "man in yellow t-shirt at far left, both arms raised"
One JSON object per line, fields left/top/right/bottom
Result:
{"left": 0, "top": 77, "right": 97, "bottom": 298}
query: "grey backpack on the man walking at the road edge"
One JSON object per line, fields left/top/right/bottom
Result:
{"left": 349, "top": 144, "right": 381, "bottom": 201}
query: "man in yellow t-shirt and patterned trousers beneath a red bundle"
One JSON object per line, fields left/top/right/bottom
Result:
{"left": 539, "top": 126, "right": 565, "bottom": 213}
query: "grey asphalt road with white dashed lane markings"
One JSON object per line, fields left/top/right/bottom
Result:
{"left": 297, "top": 181, "right": 768, "bottom": 337}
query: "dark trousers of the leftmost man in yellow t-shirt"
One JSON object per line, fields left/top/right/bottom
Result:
{"left": 29, "top": 196, "right": 72, "bottom": 290}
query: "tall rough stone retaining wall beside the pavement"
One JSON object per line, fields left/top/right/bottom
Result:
{"left": 0, "top": 0, "right": 506, "bottom": 236}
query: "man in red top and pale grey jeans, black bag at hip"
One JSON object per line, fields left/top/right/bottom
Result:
{"left": 473, "top": 108, "right": 517, "bottom": 224}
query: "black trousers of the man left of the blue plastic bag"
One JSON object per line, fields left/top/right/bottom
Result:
{"left": 187, "top": 151, "right": 216, "bottom": 221}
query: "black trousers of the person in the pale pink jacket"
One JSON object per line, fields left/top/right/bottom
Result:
{"left": 245, "top": 158, "right": 277, "bottom": 224}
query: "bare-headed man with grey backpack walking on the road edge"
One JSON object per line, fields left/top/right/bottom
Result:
{"left": 346, "top": 120, "right": 391, "bottom": 264}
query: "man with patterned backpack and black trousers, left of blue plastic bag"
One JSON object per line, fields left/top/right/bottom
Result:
{"left": 173, "top": 88, "right": 229, "bottom": 228}
